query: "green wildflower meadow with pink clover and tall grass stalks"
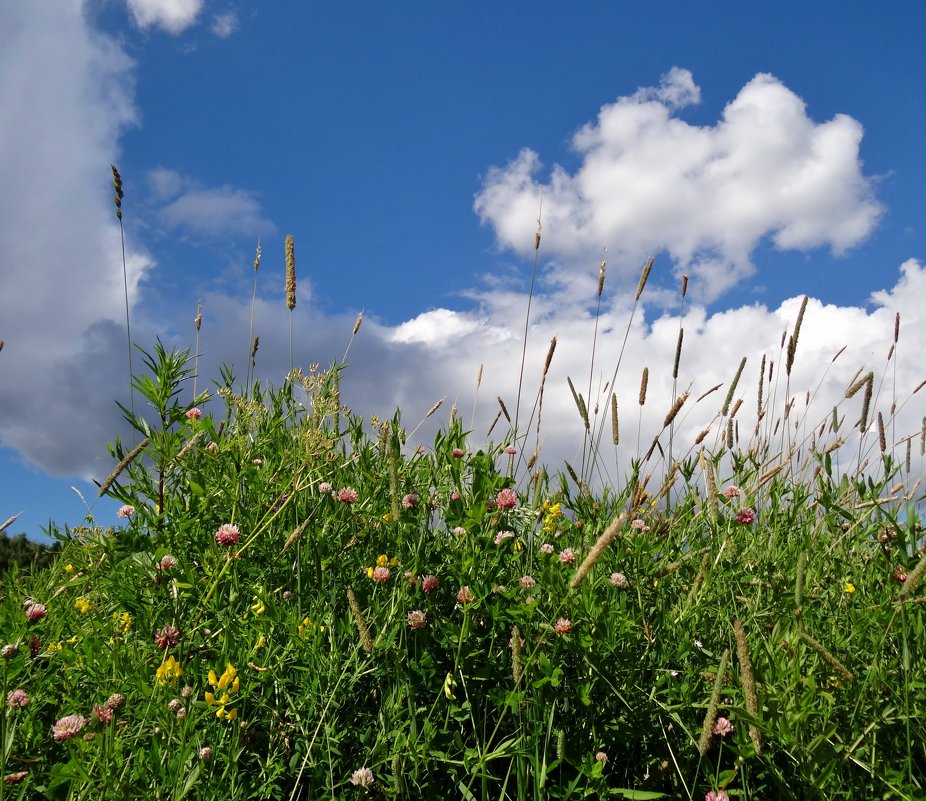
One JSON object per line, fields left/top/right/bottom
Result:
{"left": 0, "top": 228, "right": 926, "bottom": 801}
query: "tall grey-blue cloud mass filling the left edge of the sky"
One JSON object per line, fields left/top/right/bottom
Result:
{"left": 0, "top": 3, "right": 152, "bottom": 475}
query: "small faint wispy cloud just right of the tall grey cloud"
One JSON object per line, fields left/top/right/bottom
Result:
{"left": 148, "top": 168, "right": 276, "bottom": 237}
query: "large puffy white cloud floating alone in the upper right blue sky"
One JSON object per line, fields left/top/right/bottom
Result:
{"left": 475, "top": 68, "right": 882, "bottom": 300}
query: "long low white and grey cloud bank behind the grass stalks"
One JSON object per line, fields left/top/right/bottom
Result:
{"left": 178, "top": 259, "right": 926, "bottom": 500}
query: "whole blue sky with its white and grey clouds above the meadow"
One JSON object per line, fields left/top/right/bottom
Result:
{"left": 0, "top": 0, "right": 926, "bottom": 536}
